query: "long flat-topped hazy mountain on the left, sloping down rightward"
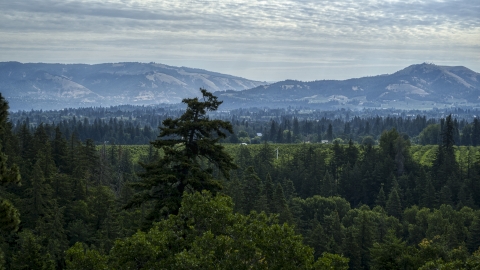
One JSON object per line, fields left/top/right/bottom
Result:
{"left": 0, "top": 62, "right": 266, "bottom": 110}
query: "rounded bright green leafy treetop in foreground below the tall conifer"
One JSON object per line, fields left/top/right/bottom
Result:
{"left": 103, "top": 192, "right": 320, "bottom": 269}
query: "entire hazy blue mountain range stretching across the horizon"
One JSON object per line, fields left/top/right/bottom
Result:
{"left": 0, "top": 62, "right": 480, "bottom": 110}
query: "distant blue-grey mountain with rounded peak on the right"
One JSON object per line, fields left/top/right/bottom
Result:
{"left": 216, "top": 63, "right": 480, "bottom": 109}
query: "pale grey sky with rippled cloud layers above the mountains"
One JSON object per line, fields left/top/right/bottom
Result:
{"left": 0, "top": 0, "right": 480, "bottom": 81}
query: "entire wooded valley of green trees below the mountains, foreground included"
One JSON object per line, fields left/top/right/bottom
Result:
{"left": 0, "top": 92, "right": 480, "bottom": 269}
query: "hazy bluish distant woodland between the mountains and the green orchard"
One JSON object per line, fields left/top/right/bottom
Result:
{"left": 10, "top": 105, "right": 480, "bottom": 146}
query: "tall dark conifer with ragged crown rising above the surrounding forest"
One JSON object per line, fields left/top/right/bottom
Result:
{"left": 126, "top": 89, "right": 236, "bottom": 221}
